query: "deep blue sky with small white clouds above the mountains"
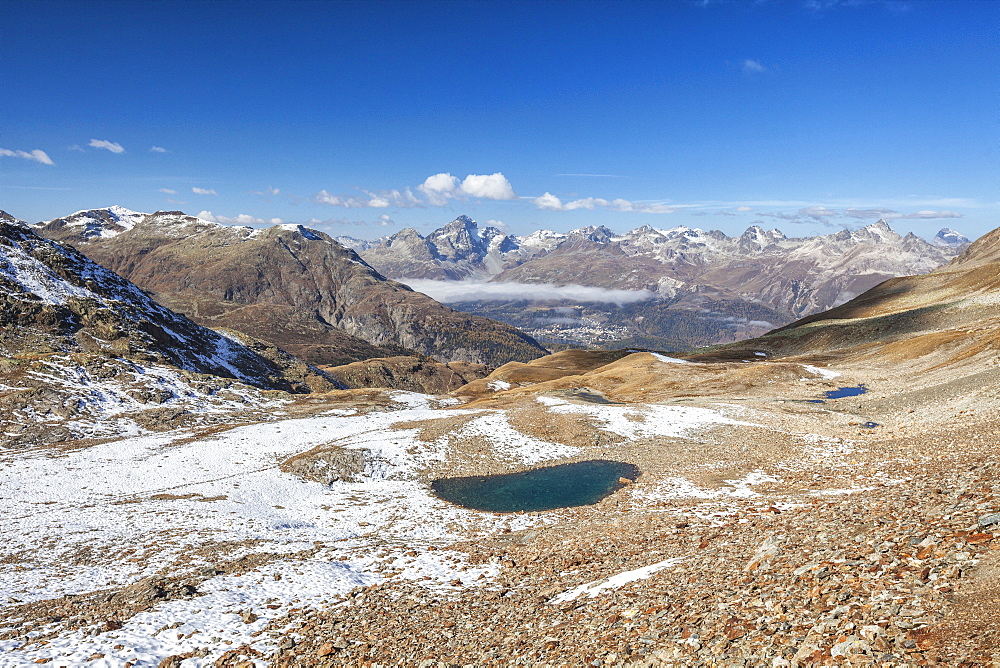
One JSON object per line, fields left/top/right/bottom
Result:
{"left": 0, "top": 0, "right": 1000, "bottom": 237}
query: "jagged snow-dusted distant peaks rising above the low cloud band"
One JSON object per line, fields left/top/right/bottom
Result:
{"left": 360, "top": 216, "right": 968, "bottom": 316}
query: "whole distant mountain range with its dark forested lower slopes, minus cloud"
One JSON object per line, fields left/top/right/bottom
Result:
{"left": 352, "top": 216, "right": 969, "bottom": 348}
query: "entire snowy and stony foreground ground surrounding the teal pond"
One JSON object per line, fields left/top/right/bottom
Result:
{"left": 0, "top": 360, "right": 1000, "bottom": 668}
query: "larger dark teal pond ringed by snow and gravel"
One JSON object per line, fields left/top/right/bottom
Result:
{"left": 431, "top": 459, "right": 639, "bottom": 513}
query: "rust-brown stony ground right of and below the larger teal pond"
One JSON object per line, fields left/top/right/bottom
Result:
{"left": 0, "top": 354, "right": 1000, "bottom": 668}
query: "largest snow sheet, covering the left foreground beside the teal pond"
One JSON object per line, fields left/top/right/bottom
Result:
{"left": 0, "top": 396, "right": 556, "bottom": 666}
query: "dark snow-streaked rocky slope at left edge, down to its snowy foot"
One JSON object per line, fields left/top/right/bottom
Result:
{"left": 0, "top": 213, "right": 340, "bottom": 447}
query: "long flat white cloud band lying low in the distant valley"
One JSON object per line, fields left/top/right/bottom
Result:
{"left": 404, "top": 279, "right": 656, "bottom": 304}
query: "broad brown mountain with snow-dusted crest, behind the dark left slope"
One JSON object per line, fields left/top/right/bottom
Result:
{"left": 36, "top": 210, "right": 544, "bottom": 366}
